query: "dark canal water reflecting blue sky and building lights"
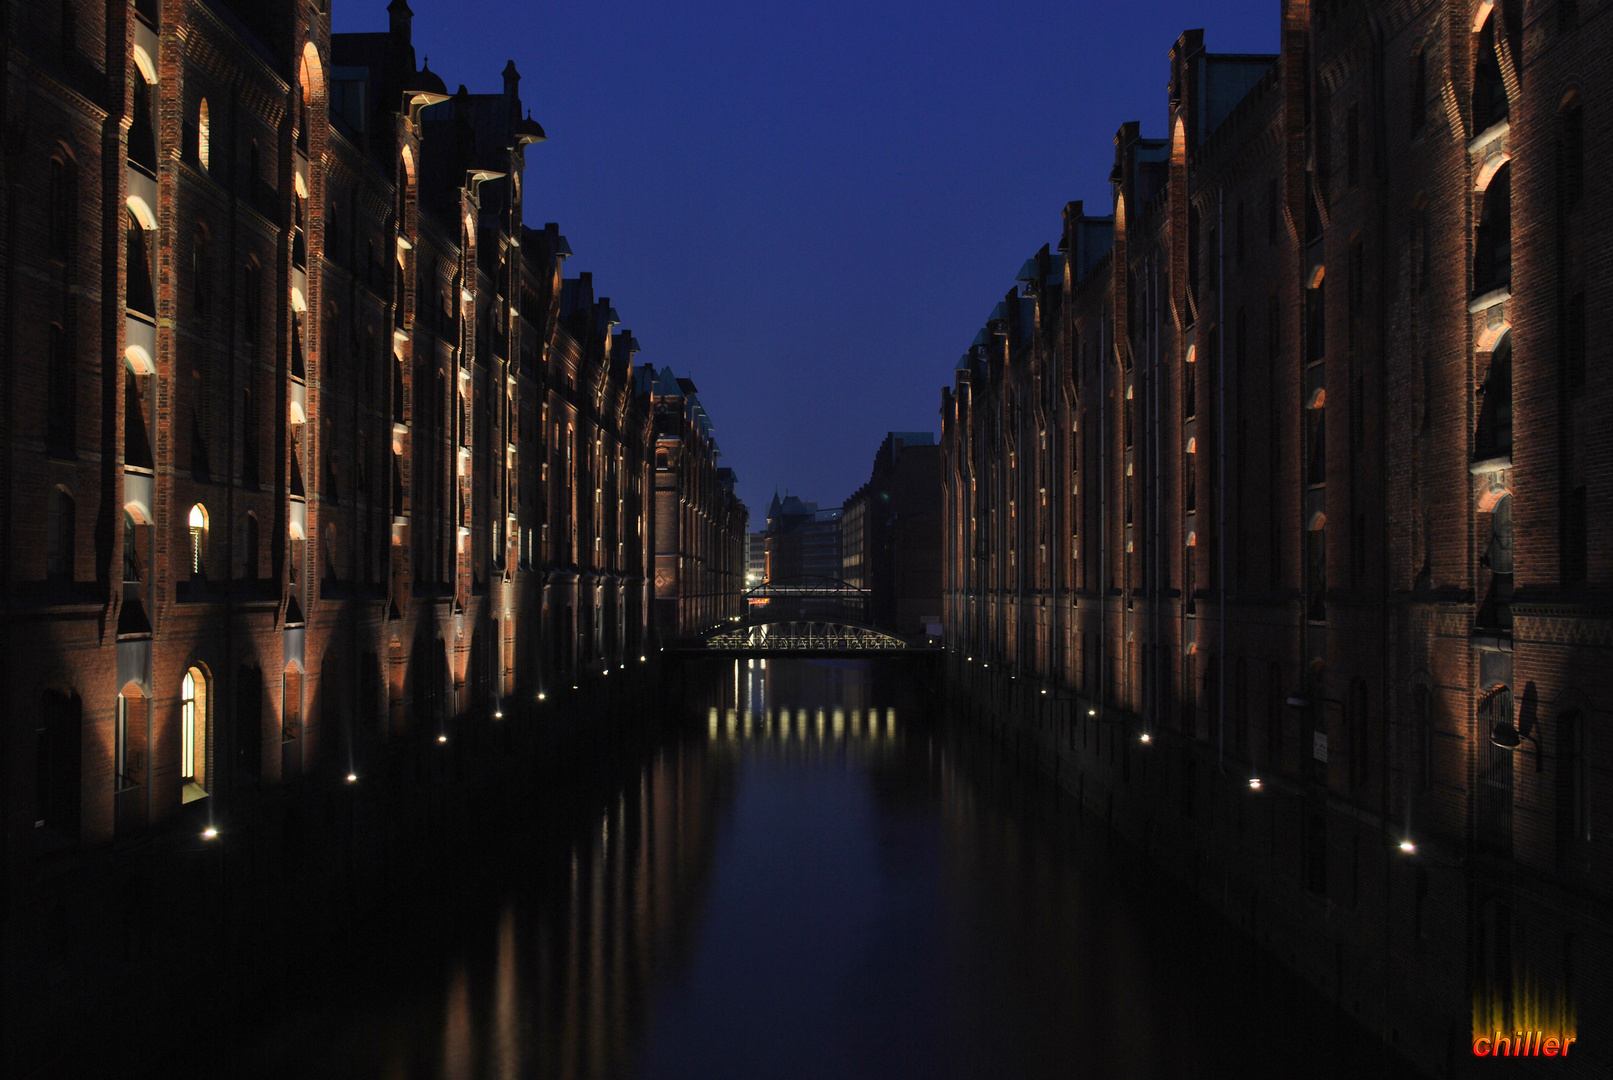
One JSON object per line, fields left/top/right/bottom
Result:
{"left": 227, "top": 661, "right": 1398, "bottom": 1080}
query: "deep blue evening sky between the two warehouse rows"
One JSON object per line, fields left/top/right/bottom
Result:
{"left": 332, "top": 0, "right": 1279, "bottom": 525}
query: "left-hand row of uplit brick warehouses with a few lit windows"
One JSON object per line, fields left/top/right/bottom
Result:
{"left": 0, "top": 0, "right": 745, "bottom": 1072}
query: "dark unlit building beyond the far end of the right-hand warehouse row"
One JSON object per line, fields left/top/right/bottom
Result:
{"left": 840, "top": 432, "right": 942, "bottom": 635}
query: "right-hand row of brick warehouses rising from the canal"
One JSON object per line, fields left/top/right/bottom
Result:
{"left": 942, "top": 0, "right": 1613, "bottom": 1075}
